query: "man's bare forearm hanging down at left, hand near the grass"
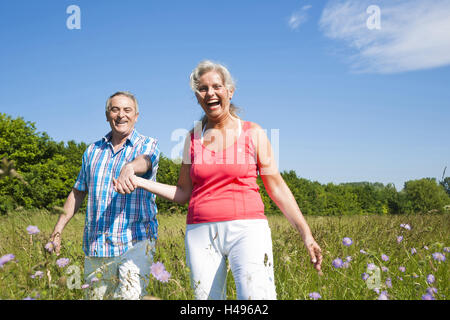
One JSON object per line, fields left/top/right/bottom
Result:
{"left": 50, "top": 188, "right": 87, "bottom": 254}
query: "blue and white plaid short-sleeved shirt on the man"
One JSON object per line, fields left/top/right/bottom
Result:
{"left": 74, "top": 129, "right": 159, "bottom": 257}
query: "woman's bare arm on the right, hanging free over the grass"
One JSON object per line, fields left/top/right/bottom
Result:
{"left": 252, "top": 124, "right": 322, "bottom": 271}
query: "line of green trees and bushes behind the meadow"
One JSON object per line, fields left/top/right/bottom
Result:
{"left": 0, "top": 113, "right": 450, "bottom": 215}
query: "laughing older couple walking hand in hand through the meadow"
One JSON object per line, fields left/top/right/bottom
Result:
{"left": 51, "top": 61, "right": 322, "bottom": 299}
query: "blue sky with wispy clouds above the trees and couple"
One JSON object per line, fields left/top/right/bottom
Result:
{"left": 0, "top": 0, "right": 450, "bottom": 190}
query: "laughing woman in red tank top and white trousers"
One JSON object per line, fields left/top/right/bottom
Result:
{"left": 114, "top": 61, "right": 322, "bottom": 299}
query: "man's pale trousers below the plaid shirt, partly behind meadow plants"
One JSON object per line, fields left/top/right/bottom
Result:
{"left": 84, "top": 240, "right": 155, "bottom": 300}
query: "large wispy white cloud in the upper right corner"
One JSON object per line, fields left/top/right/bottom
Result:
{"left": 319, "top": 0, "right": 450, "bottom": 73}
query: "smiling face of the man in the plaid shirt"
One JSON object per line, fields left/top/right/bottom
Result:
{"left": 106, "top": 95, "right": 139, "bottom": 137}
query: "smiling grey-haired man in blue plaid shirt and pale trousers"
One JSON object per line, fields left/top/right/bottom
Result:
{"left": 51, "top": 92, "right": 159, "bottom": 300}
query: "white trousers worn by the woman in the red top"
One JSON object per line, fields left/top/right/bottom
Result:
{"left": 185, "top": 219, "right": 276, "bottom": 300}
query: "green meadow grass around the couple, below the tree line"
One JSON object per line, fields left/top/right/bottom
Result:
{"left": 0, "top": 211, "right": 450, "bottom": 300}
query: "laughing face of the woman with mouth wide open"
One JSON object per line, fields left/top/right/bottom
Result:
{"left": 196, "top": 71, "right": 233, "bottom": 119}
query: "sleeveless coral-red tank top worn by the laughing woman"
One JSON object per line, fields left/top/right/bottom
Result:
{"left": 187, "top": 121, "right": 267, "bottom": 224}
